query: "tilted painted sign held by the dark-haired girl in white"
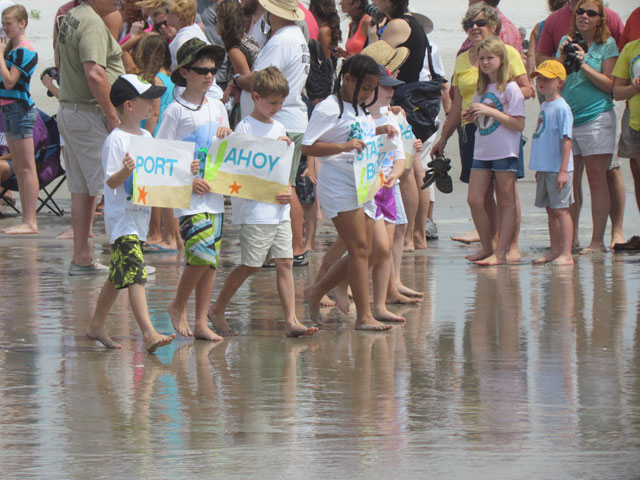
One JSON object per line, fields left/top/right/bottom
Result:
{"left": 353, "top": 135, "right": 394, "bottom": 205}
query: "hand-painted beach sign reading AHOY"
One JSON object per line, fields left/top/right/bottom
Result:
{"left": 204, "top": 133, "right": 295, "bottom": 203}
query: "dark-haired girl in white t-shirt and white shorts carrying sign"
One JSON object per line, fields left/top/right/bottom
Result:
{"left": 302, "top": 55, "right": 395, "bottom": 331}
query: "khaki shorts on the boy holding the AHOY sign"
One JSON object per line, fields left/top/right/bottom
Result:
{"left": 240, "top": 222, "right": 293, "bottom": 267}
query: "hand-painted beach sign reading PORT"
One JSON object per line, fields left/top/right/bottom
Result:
{"left": 129, "top": 137, "right": 195, "bottom": 208}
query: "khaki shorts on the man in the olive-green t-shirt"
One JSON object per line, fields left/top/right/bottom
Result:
{"left": 57, "top": 104, "right": 109, "bottom": 196}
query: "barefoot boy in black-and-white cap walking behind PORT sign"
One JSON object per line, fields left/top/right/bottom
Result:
{"left": 86, "top": 75, "right": 176, "bottom": 353}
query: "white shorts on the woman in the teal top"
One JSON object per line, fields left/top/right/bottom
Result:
{"left": 571, "top": 109, "right": 616, "bottom": 157}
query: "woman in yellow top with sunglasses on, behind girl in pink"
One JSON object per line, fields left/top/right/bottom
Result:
{"left": 431, "top": 2, "right": 534, "bottom": 249}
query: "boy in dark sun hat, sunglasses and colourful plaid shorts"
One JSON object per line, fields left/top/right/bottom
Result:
{"left": 157, "top": 38, "right": 232, "bottom": 342}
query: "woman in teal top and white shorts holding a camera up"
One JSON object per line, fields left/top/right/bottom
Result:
{"left": 556, "top": 0, "right": 619, "bottom": 254}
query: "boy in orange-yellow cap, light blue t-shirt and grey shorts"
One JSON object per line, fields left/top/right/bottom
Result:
{"left": 529, "top": 60, "right": 573, "bottom": 265}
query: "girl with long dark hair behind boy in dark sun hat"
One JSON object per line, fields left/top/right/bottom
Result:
{"left": 216, "top": 0, "right": 260, "bottom": 128}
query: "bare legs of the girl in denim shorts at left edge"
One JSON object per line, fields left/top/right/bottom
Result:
{"left": 2, "top": 136, "right": 39, "bottom": 235}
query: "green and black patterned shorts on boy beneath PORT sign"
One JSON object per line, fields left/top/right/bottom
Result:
{"left": 109, "top": 235, "right": 147, "bottom": 290}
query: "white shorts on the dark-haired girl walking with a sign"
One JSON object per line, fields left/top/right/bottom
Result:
{"left": 316, "top": 162, "right": 377, "bottom": 220}
